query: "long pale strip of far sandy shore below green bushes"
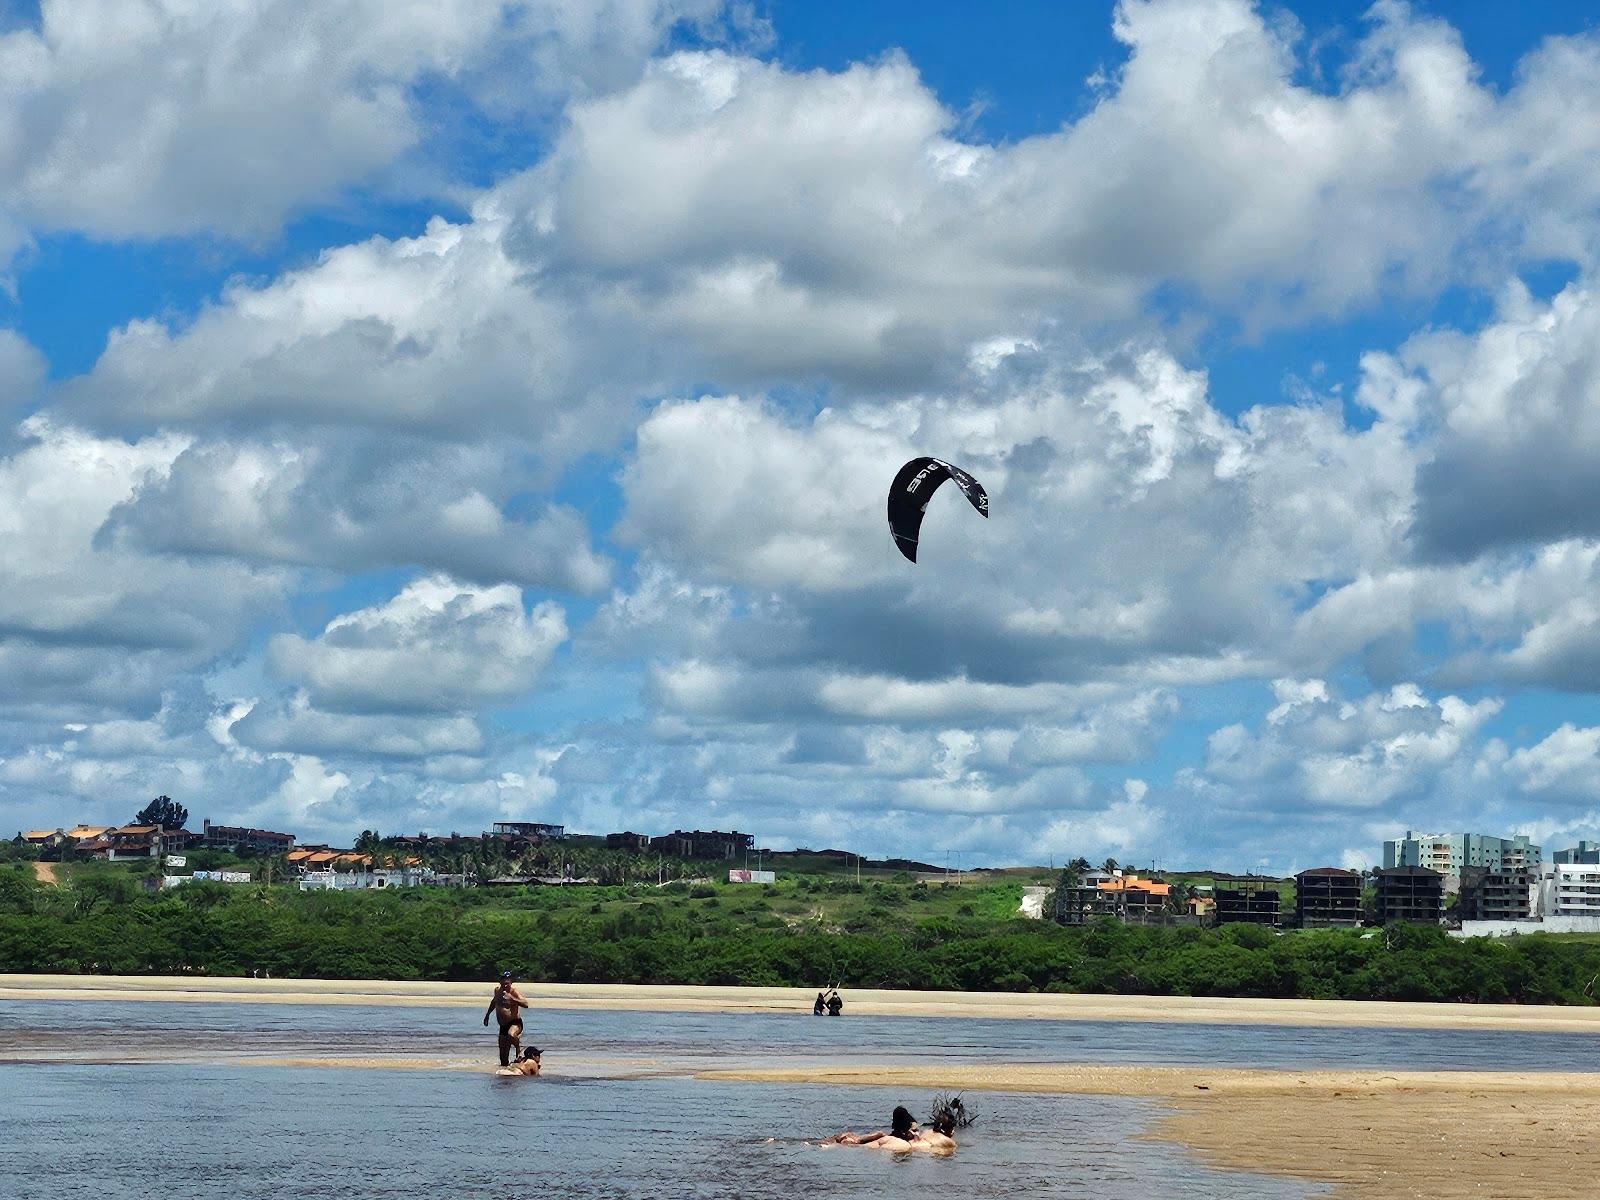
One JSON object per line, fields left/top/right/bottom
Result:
{"left": 9, "top": 974, "right": 1600, "bottom": 1034}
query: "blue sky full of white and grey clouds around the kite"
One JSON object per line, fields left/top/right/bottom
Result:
{"left": 0, "top": 0, "right": 1600, "bottom": 869}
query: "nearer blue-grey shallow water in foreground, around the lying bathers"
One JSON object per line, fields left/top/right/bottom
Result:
{"left": 0, "top": 1064, "right": 1315, "bottom": 1200}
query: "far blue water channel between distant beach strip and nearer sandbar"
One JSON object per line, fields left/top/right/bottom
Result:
{"left": 0, "top": 992, "right": 1600, "bottom": 1072}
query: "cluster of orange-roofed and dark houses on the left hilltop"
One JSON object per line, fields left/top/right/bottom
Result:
{"left": 18, "top": 821, "right": 755, "bottom": 891}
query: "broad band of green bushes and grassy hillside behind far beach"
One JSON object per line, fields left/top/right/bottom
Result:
{"left": 9, "top": 862, "right": 1600, "bottom": 1003}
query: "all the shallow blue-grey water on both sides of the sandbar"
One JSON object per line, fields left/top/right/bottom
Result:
{"left": 0, "top": 992, "right": 1600, "bottom": 1200}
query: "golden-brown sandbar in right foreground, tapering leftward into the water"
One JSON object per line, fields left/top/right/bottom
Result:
{"left": 699, "top": 1064, "right": 1600, "bottom": 1200}
